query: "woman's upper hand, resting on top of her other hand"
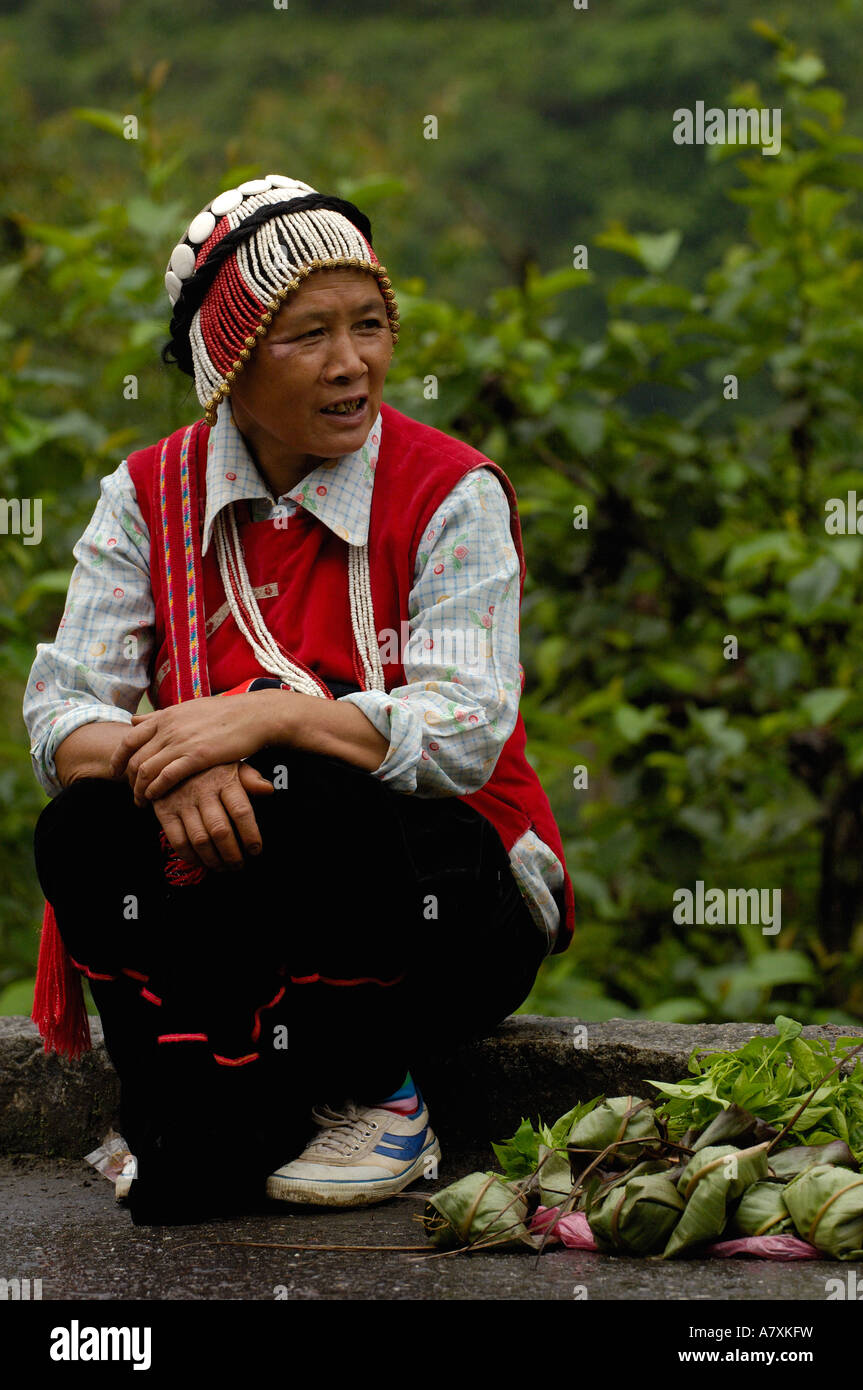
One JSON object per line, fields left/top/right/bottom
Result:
{"left": 111, "top": 691, "right": 277, "bottom": 806}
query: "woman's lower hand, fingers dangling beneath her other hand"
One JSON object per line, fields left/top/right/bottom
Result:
{"left": 153, "top": 761, "right": 274, "bottom": 870}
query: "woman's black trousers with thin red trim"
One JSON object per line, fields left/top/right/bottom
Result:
{"left": 35, "top": 748, "right": 545, "bottom": 1222}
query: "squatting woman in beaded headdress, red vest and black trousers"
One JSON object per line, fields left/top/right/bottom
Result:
{"left": 25, "top": 175, "right": 574, "bottom": 1222}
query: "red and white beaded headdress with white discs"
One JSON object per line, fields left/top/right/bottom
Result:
{"left": 165, "top": 174, "right": 399, "bottom": 425}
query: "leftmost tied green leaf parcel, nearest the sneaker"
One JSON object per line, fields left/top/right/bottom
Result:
{"left": 420, "top": 1173, "right": 536, "bottom": 1250}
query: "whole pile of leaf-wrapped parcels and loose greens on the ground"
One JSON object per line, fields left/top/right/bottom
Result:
{"left": 421, "top": 1016, "right": 863, "bottom": 1259}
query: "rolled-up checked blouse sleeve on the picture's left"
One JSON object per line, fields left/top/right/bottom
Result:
{"left": 24, "top": 463, "right": 154, "bottom": 796}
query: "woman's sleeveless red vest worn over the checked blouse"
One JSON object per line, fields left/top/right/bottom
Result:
{"left": 128, "top": 404, "right": 575, "bottom": 954}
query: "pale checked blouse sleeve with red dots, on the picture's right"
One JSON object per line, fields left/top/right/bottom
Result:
{"left": 342, "top": 468, "right": 521, "bottom": 796}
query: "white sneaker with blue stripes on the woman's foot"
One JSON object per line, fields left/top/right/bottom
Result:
{"left": 267, "top": 1091, "right": 441, "bottom": 1207}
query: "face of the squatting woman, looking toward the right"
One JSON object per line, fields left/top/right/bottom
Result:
{"left": 231, "top": 267, "right": 393, "bottom": 459}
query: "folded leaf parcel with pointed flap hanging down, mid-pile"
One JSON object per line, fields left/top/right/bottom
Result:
{"left": 663, "top": 1144, "right": 767, "bottom": 1259}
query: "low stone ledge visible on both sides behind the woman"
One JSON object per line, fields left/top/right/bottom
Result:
{"left": 0, "top": 1015, "right": 863, "bottom": 1161}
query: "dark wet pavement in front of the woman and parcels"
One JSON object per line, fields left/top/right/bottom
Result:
{"left": 0, "top": 1154, "right": 863, "bottom": 1301}
